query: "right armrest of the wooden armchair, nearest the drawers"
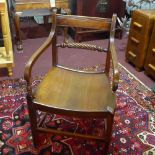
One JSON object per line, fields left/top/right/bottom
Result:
{"left": 110, "top": 38, "right": 119, "bottom": 91}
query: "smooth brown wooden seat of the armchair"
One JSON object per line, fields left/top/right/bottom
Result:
{"left": 33, "top": 67, "right": 115, "bottom": 113}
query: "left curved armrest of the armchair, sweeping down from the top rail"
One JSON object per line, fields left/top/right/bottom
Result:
{"left": 24, "top": 11, "right": 56, "bottom": 96}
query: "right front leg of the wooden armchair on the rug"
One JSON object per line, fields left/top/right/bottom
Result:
{"left": 104, "top": 114, "right": 114, "bottom": 155}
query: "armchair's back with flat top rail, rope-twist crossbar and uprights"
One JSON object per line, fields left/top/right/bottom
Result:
{"left": 52, "top": 8, "right": 117, "bottom": 77}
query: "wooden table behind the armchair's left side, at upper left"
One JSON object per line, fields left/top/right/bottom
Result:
{"left": 12, "top": 0, "right": 70, "bottom": 50}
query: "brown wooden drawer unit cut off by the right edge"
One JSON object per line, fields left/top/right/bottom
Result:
{"left": 144, "top": 21, "right": 155, "bottom": 79}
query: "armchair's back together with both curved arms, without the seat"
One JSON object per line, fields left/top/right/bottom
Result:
{"left": 25, "top": 8, "right": 119, "bottom": 92}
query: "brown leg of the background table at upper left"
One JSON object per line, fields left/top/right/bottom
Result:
{"left": 14, "top": 14, "right": 23, "bottom": 50}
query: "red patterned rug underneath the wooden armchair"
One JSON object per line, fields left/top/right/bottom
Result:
{"left": 0, "top": 66, "right": 155, "bottom": 155}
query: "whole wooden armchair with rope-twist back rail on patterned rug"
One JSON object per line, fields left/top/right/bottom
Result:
{"left": 24, "top": 8, "right": 119, "bottom": 154}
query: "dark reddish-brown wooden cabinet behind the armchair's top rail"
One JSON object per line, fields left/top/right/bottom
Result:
{"left": 70, "top": 0, "right": 125, "bottom": 41}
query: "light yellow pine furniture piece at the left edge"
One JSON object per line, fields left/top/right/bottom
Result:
{"left": 0, "top": 0, "right": 14, "bottom": 76}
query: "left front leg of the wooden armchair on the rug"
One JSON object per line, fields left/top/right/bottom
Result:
{"left": 27, "top": 96, "right": 37, "bottom": 147}
